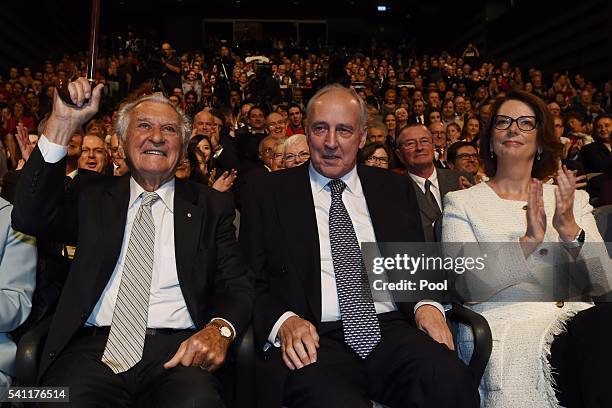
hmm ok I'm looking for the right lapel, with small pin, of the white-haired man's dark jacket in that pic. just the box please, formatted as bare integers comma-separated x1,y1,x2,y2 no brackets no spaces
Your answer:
174,179,206,326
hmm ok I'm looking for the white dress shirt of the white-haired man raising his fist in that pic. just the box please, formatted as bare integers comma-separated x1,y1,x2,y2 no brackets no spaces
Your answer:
38,135,236,333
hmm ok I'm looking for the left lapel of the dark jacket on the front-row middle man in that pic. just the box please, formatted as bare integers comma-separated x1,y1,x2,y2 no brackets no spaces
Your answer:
274,164,321,321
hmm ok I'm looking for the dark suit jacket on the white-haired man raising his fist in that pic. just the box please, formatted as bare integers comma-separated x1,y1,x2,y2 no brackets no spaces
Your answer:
13,148,253,379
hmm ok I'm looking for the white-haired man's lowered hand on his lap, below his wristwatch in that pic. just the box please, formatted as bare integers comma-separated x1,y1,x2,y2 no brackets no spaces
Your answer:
164,325,230,372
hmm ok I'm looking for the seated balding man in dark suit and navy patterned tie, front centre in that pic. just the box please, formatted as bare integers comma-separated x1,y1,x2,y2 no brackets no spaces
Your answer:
240,84,478,407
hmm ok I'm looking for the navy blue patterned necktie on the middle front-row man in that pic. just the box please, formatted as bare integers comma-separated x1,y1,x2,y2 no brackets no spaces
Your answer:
329,179,381,358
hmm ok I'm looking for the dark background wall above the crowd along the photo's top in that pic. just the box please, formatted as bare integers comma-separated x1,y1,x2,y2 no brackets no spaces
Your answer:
0,0,612,80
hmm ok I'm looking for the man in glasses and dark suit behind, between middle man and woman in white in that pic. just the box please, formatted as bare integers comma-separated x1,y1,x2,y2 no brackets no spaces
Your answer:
396,124,468,242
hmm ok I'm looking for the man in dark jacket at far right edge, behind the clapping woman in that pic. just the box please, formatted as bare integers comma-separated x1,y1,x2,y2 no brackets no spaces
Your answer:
580,113,612,173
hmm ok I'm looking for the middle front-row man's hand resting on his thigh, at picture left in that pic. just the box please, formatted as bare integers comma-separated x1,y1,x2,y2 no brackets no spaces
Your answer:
278,316,319,370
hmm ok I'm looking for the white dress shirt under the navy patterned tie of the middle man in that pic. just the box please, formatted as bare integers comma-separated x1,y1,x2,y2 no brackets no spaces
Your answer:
264,163,444,350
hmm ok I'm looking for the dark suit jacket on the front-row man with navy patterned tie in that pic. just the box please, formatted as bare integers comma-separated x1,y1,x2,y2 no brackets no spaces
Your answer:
240,164,423,407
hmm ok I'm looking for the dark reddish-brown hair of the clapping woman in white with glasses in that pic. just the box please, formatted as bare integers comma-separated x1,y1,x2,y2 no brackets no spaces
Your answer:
480,91,563,179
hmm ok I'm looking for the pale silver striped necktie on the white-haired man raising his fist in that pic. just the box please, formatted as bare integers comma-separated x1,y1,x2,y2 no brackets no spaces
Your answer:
102,192,159,374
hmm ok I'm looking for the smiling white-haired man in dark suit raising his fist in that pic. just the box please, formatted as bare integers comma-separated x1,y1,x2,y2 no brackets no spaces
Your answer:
13,78,252,407
